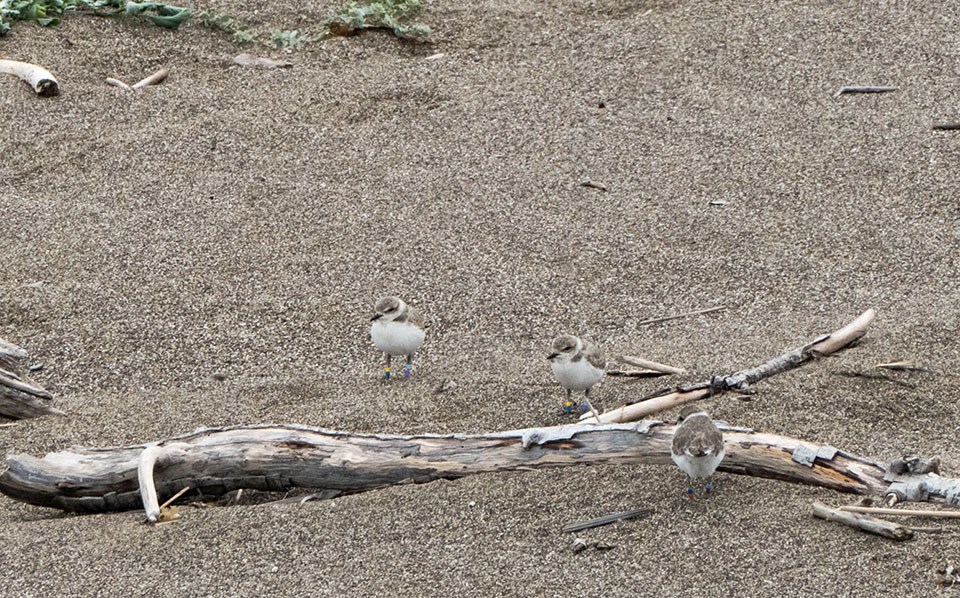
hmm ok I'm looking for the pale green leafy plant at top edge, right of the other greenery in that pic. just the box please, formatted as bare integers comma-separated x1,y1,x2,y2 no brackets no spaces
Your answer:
326,0,430,40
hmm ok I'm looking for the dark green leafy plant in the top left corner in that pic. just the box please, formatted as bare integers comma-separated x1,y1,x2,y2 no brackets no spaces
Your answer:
0,0,192,35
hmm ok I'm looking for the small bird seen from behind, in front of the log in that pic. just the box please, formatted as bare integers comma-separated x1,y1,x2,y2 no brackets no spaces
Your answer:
670,405,724,498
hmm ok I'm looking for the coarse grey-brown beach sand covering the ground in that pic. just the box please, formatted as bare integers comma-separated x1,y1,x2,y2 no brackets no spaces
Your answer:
0,0,960,596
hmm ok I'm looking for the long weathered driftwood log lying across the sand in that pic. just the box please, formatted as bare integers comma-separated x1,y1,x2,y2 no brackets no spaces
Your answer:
0,421,960,520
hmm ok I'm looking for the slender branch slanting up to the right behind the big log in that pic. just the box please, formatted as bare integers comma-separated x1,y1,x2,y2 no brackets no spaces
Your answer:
580,309,876,423
